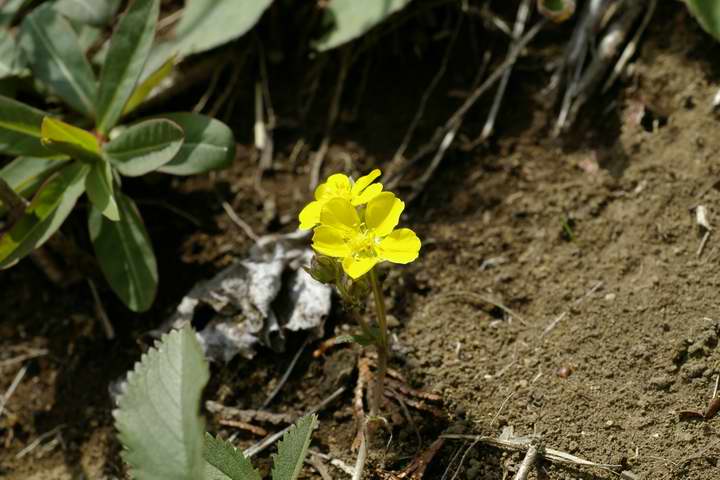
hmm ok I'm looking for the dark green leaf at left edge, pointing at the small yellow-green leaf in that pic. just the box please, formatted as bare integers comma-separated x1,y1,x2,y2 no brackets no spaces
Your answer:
0,92,56,157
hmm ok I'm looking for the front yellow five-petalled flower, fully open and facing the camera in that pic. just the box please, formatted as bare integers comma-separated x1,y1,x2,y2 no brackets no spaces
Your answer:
313,192,420,279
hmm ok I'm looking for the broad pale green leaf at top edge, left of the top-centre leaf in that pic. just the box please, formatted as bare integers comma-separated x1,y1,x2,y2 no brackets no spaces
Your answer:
175,0,272,56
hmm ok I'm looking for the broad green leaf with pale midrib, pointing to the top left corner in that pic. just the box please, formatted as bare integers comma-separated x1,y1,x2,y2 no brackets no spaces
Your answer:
20,4,97,118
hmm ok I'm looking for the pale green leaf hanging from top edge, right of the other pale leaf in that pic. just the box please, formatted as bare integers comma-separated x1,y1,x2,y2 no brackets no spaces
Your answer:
315,0,410,51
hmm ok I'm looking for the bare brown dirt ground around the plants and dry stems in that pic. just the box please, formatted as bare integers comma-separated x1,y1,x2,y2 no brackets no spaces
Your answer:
0,4,720,480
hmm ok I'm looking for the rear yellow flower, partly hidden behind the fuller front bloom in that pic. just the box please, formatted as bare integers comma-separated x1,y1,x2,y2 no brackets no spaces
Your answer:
300,168,382,230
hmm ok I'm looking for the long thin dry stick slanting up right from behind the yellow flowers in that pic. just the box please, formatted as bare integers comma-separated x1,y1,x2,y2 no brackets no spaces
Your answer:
388,18,548,193
